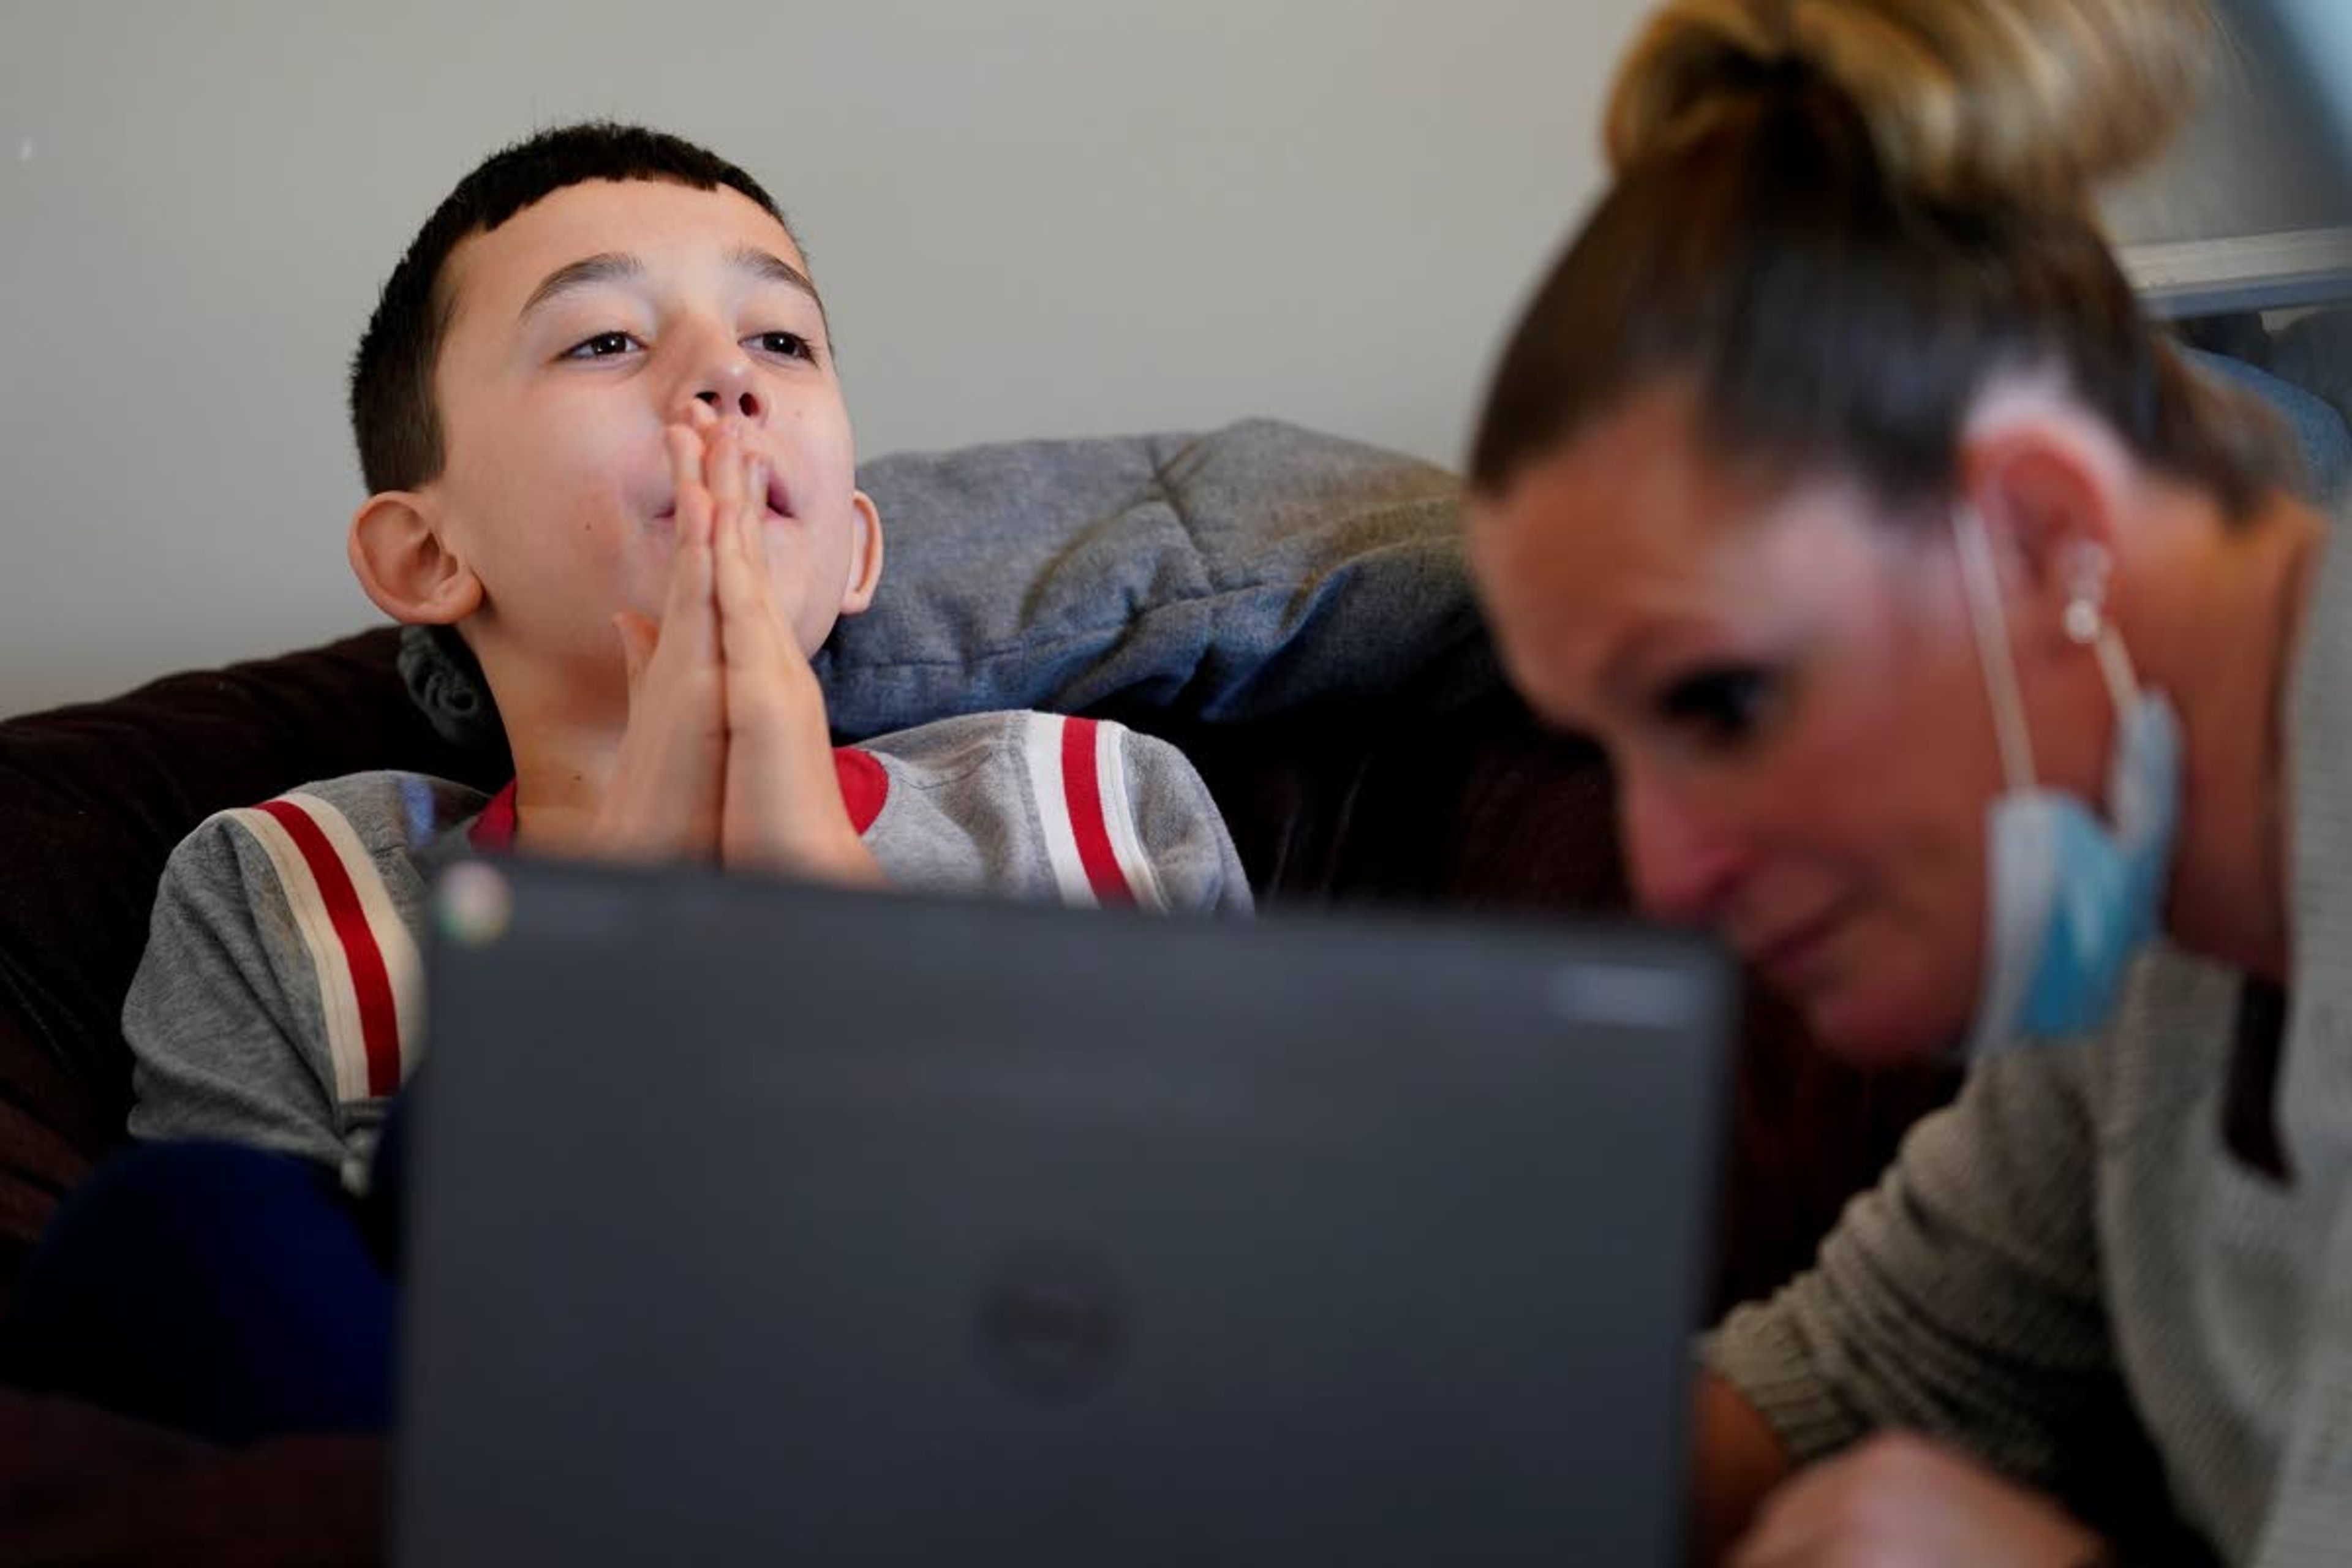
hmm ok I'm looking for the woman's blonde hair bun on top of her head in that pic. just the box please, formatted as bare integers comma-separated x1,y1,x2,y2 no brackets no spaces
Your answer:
1607,0,2218,209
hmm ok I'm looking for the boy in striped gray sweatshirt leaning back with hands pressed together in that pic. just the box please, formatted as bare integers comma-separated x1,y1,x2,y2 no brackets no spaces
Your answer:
0,124,1249,1441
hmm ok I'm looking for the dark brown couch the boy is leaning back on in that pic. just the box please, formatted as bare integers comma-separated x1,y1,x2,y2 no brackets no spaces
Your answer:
0,630,1950,1563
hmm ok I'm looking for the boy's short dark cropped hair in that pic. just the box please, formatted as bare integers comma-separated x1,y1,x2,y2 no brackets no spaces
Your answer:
350,120,800,494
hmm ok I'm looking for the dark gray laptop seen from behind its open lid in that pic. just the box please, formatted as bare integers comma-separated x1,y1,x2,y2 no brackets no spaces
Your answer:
398,863,1731,1566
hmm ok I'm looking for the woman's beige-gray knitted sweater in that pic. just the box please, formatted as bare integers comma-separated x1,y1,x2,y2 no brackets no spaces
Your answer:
1700,522,2352,1568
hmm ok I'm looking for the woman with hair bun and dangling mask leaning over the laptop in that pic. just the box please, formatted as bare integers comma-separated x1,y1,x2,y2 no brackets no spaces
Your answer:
1470,0,2352,1566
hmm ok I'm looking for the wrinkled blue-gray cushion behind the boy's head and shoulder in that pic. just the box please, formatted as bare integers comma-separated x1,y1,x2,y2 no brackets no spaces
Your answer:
402,418,1493,741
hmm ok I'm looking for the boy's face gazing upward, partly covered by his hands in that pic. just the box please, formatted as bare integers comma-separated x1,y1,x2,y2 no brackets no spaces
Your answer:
421,181,873,696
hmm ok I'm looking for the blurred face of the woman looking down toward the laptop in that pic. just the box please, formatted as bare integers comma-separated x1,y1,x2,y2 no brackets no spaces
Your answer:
1470,390,2002,1058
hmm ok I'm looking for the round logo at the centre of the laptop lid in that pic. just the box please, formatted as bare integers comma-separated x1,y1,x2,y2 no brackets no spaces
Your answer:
974,1242,1129,1406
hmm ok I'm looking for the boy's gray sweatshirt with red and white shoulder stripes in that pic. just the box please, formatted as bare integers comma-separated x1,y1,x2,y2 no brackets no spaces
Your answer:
123,712,1249,1173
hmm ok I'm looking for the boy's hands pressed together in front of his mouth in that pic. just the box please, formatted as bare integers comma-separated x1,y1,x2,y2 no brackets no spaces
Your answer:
597,404,882,881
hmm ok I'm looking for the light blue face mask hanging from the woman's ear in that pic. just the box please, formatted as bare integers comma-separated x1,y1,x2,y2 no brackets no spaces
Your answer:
1954,510,2180,1058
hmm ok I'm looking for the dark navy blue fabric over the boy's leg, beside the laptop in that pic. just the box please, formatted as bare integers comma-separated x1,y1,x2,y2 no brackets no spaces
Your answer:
0,1119,398,1444
